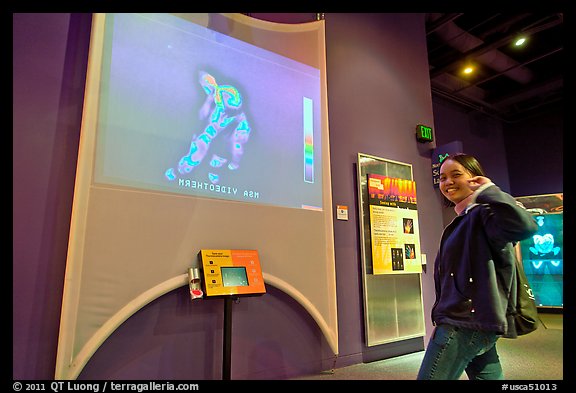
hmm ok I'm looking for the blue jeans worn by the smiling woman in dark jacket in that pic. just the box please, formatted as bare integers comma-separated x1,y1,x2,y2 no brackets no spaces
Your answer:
417,325,504,380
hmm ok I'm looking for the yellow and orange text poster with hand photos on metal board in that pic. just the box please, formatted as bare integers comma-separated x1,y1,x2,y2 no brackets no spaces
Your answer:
367,174,422,274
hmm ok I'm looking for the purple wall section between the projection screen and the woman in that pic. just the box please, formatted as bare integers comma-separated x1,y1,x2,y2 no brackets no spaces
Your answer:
326,14,442,365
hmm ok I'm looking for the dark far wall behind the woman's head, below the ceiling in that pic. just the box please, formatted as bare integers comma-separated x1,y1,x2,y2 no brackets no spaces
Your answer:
433,98,564,196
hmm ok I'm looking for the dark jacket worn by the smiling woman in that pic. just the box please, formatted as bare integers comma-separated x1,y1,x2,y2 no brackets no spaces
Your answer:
432,183,538,336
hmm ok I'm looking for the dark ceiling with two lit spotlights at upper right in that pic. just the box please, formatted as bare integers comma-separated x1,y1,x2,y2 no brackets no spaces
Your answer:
426,12,565,123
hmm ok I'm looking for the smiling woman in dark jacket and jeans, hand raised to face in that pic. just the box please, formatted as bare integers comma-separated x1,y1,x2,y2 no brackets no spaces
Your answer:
418,153,537,380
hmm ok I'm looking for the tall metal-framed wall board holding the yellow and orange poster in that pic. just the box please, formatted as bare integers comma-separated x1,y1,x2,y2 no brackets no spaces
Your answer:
357,153,425,349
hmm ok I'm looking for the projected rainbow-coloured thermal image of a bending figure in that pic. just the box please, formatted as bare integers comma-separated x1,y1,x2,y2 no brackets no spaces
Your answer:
165,72,251,184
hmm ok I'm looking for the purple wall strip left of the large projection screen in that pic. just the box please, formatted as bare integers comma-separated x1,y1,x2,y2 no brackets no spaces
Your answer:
12,14,90,379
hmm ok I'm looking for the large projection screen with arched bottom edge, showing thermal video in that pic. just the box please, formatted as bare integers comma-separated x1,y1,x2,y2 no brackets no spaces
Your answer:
55,14,338,379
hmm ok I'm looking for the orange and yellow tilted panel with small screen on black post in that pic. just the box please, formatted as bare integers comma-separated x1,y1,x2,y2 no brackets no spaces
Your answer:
198,250,266,296
